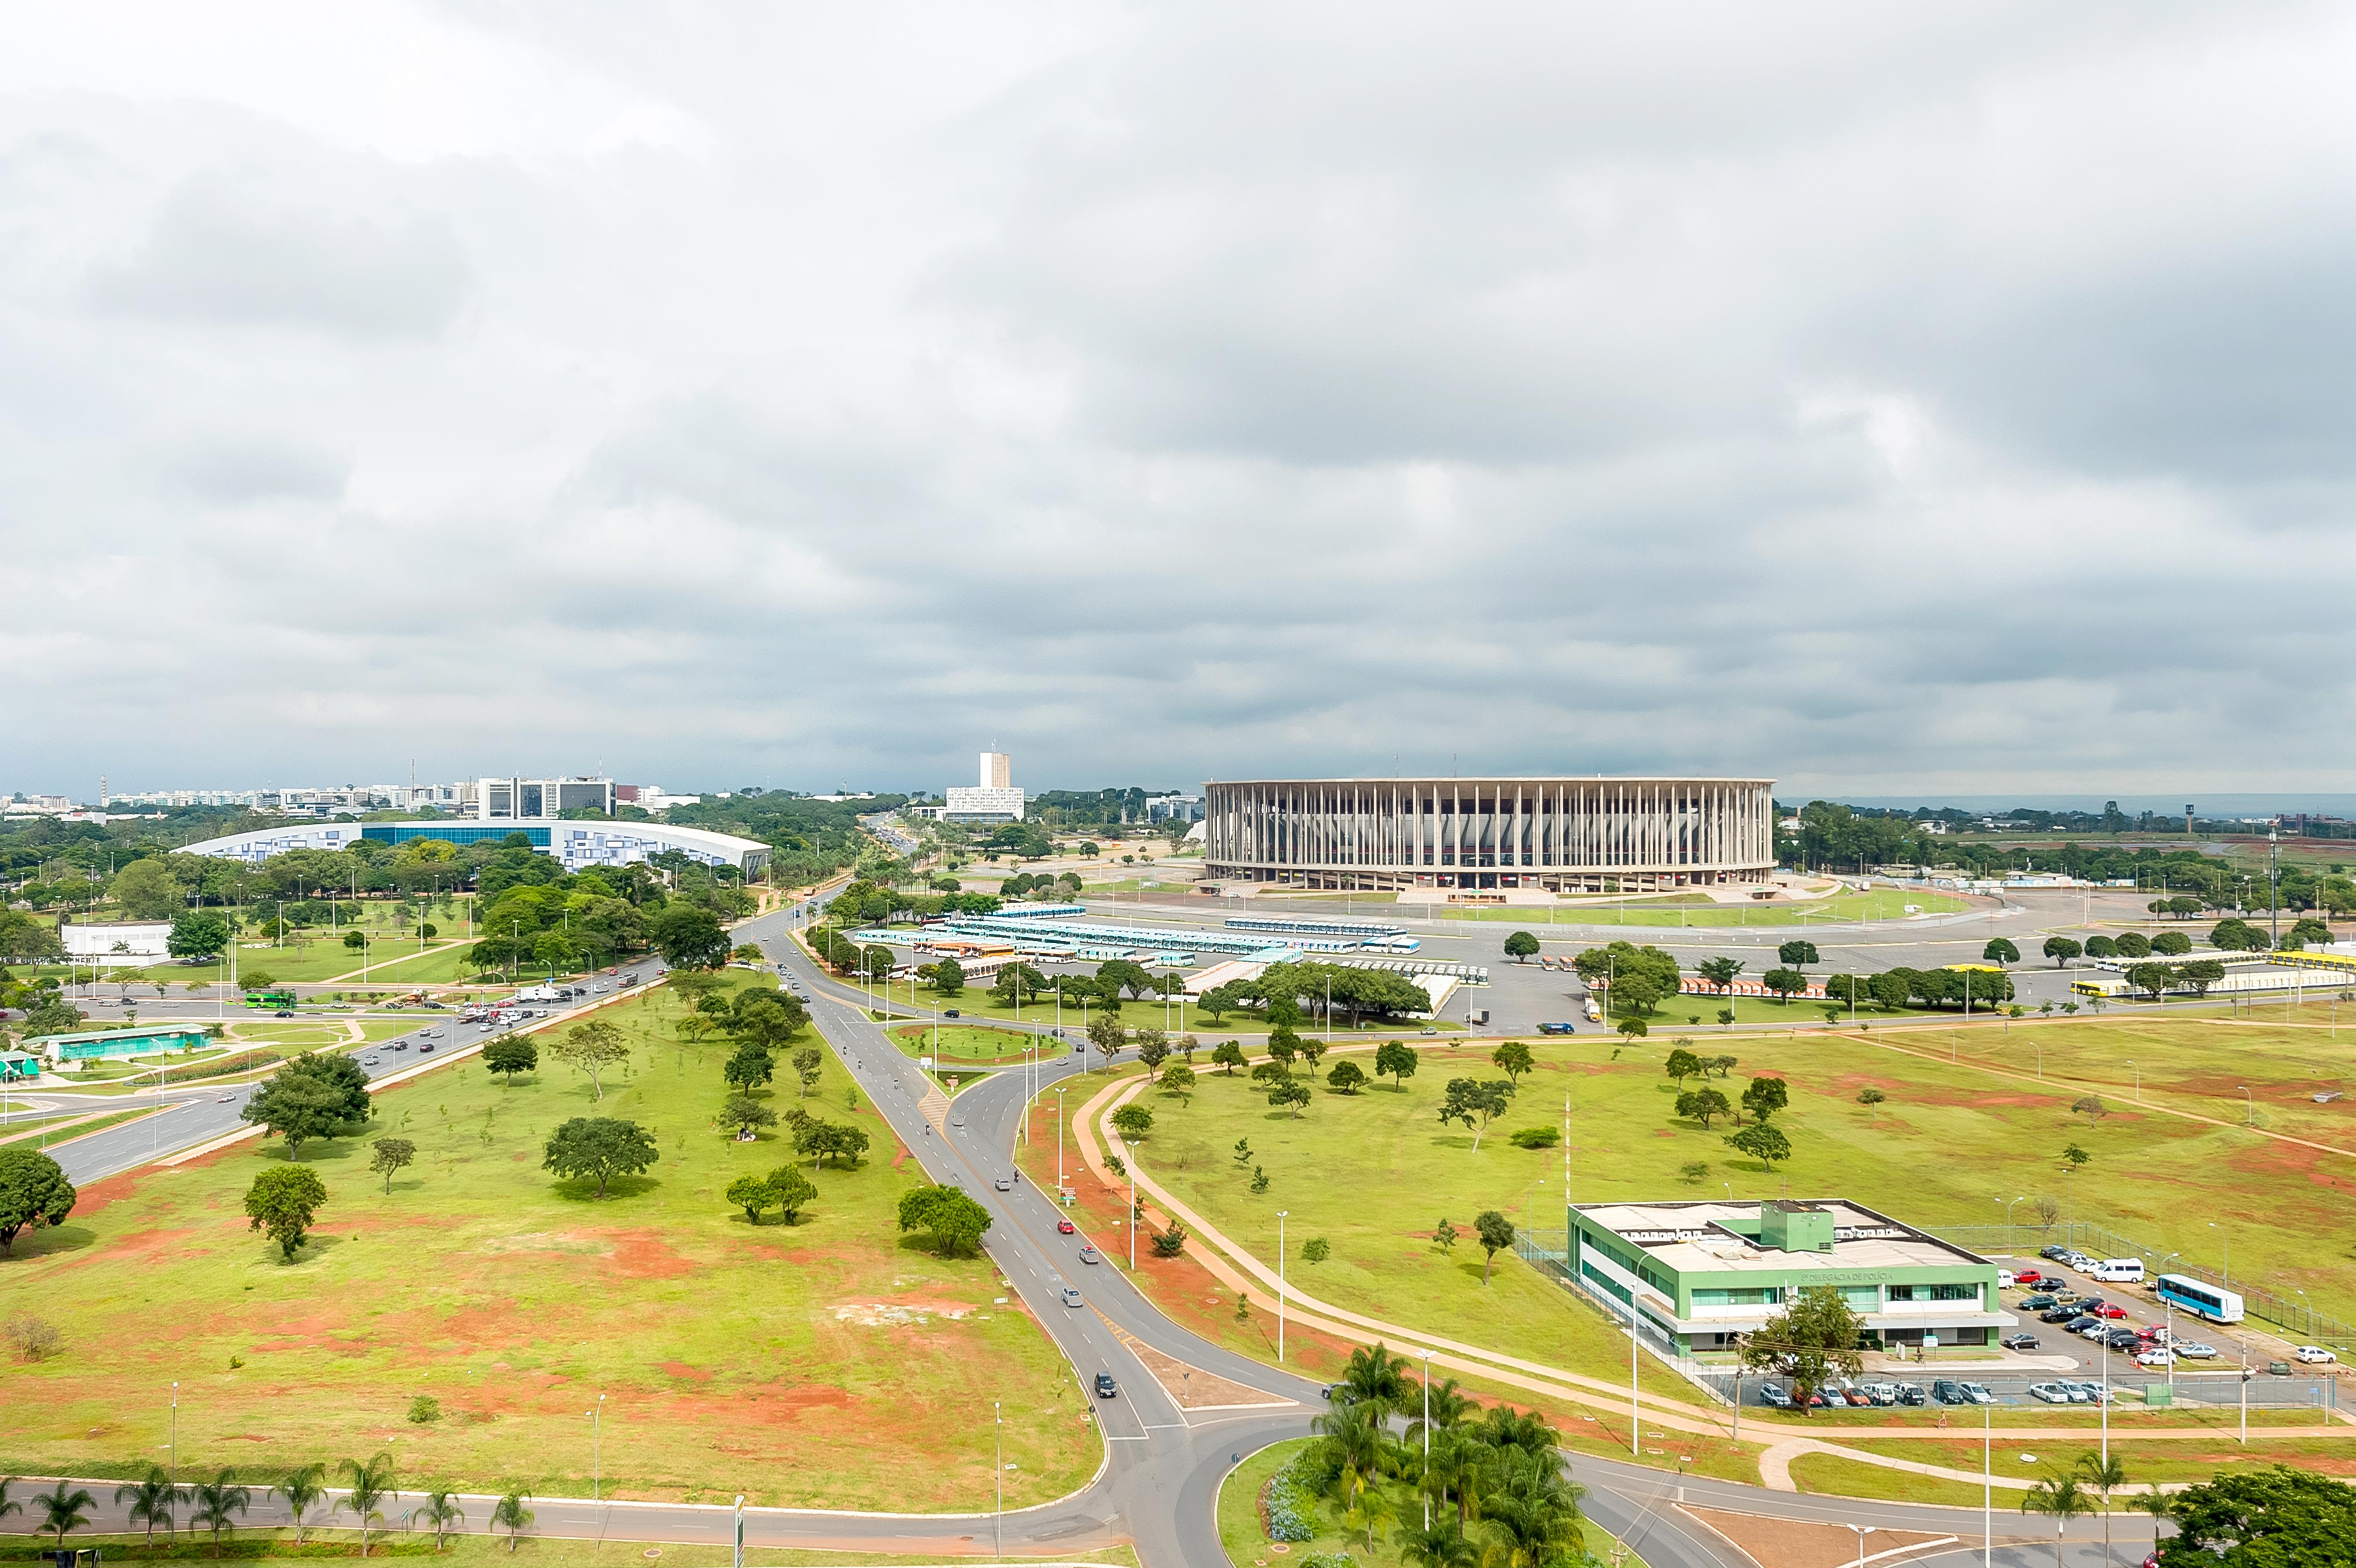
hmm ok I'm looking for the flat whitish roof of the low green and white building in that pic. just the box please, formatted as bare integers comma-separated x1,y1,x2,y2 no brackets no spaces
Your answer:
1574,1198,1986,1274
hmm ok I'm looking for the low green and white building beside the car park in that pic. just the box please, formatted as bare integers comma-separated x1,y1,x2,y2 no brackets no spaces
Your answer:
1567,1198,2019,1356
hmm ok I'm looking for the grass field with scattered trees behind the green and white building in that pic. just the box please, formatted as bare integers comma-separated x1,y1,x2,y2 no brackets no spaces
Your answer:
1145,1019,2356,1375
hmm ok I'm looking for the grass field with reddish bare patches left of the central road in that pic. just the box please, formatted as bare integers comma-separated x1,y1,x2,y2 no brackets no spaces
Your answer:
0,991,1100,1512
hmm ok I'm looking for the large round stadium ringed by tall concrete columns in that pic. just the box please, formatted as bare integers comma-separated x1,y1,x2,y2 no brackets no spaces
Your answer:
1204,777,1774,893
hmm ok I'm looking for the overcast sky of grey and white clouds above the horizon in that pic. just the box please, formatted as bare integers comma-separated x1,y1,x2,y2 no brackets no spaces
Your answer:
0,0,2356,798
